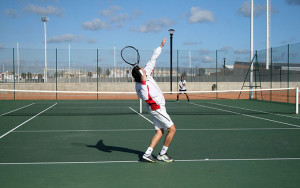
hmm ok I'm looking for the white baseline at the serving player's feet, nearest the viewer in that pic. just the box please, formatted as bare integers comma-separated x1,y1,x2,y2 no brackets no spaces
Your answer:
0,158,300,165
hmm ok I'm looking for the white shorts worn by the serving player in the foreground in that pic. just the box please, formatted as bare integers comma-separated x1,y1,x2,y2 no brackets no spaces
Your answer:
149,106,174,130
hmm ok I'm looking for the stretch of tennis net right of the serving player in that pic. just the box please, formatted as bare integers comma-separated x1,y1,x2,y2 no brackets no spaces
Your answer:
164,88,299,115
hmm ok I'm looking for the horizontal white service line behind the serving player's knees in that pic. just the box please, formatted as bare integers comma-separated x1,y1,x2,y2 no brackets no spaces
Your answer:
14,128,300,133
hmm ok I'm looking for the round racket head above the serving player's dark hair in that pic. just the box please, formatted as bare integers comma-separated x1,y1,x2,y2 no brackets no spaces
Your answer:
121,46,140,66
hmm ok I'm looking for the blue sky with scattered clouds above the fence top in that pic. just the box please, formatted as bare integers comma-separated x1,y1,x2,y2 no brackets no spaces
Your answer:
0,0,300,52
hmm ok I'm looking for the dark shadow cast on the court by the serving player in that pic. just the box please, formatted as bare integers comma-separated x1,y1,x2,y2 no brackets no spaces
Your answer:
86,140,144,161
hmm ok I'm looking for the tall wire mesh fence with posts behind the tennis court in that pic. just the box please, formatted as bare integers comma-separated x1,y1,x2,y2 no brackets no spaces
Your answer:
0,43,300,91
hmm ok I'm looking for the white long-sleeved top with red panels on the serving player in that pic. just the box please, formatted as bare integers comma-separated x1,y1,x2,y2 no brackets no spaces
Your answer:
135,47,165,110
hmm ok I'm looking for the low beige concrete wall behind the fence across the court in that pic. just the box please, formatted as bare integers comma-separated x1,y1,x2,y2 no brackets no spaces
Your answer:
0,82,300,92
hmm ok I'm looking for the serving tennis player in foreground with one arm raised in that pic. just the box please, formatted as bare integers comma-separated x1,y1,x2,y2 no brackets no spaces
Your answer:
132,38,176,162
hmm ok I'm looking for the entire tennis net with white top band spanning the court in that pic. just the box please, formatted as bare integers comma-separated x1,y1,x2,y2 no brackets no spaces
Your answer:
0,88,299,115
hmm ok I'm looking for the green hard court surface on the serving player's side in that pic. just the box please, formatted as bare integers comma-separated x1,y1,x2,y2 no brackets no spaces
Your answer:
0,100,300,188
